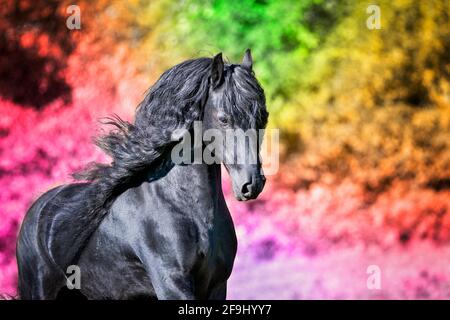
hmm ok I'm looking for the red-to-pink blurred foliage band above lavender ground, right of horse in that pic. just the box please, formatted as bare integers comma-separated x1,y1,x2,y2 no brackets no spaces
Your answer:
227,178,450,256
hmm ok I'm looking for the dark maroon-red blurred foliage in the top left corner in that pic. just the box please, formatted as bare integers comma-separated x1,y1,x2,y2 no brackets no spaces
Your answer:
0,0,74,108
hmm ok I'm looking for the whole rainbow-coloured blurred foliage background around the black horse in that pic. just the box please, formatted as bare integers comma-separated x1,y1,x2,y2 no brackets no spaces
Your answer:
0,0,450,299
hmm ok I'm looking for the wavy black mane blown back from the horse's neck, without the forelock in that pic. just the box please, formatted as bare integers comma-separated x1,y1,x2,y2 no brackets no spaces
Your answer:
74,58,212,182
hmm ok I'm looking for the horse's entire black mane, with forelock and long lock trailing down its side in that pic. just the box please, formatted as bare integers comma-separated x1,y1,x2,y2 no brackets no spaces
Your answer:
43,58,268,267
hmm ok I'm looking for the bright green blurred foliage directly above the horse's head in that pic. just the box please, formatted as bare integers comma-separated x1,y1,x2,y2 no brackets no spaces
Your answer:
174,0,321,106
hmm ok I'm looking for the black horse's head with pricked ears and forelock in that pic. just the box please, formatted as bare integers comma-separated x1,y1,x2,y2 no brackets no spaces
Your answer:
203,50,268,201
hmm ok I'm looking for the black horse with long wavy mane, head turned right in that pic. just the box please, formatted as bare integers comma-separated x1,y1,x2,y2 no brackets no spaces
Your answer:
17,50,268,299
